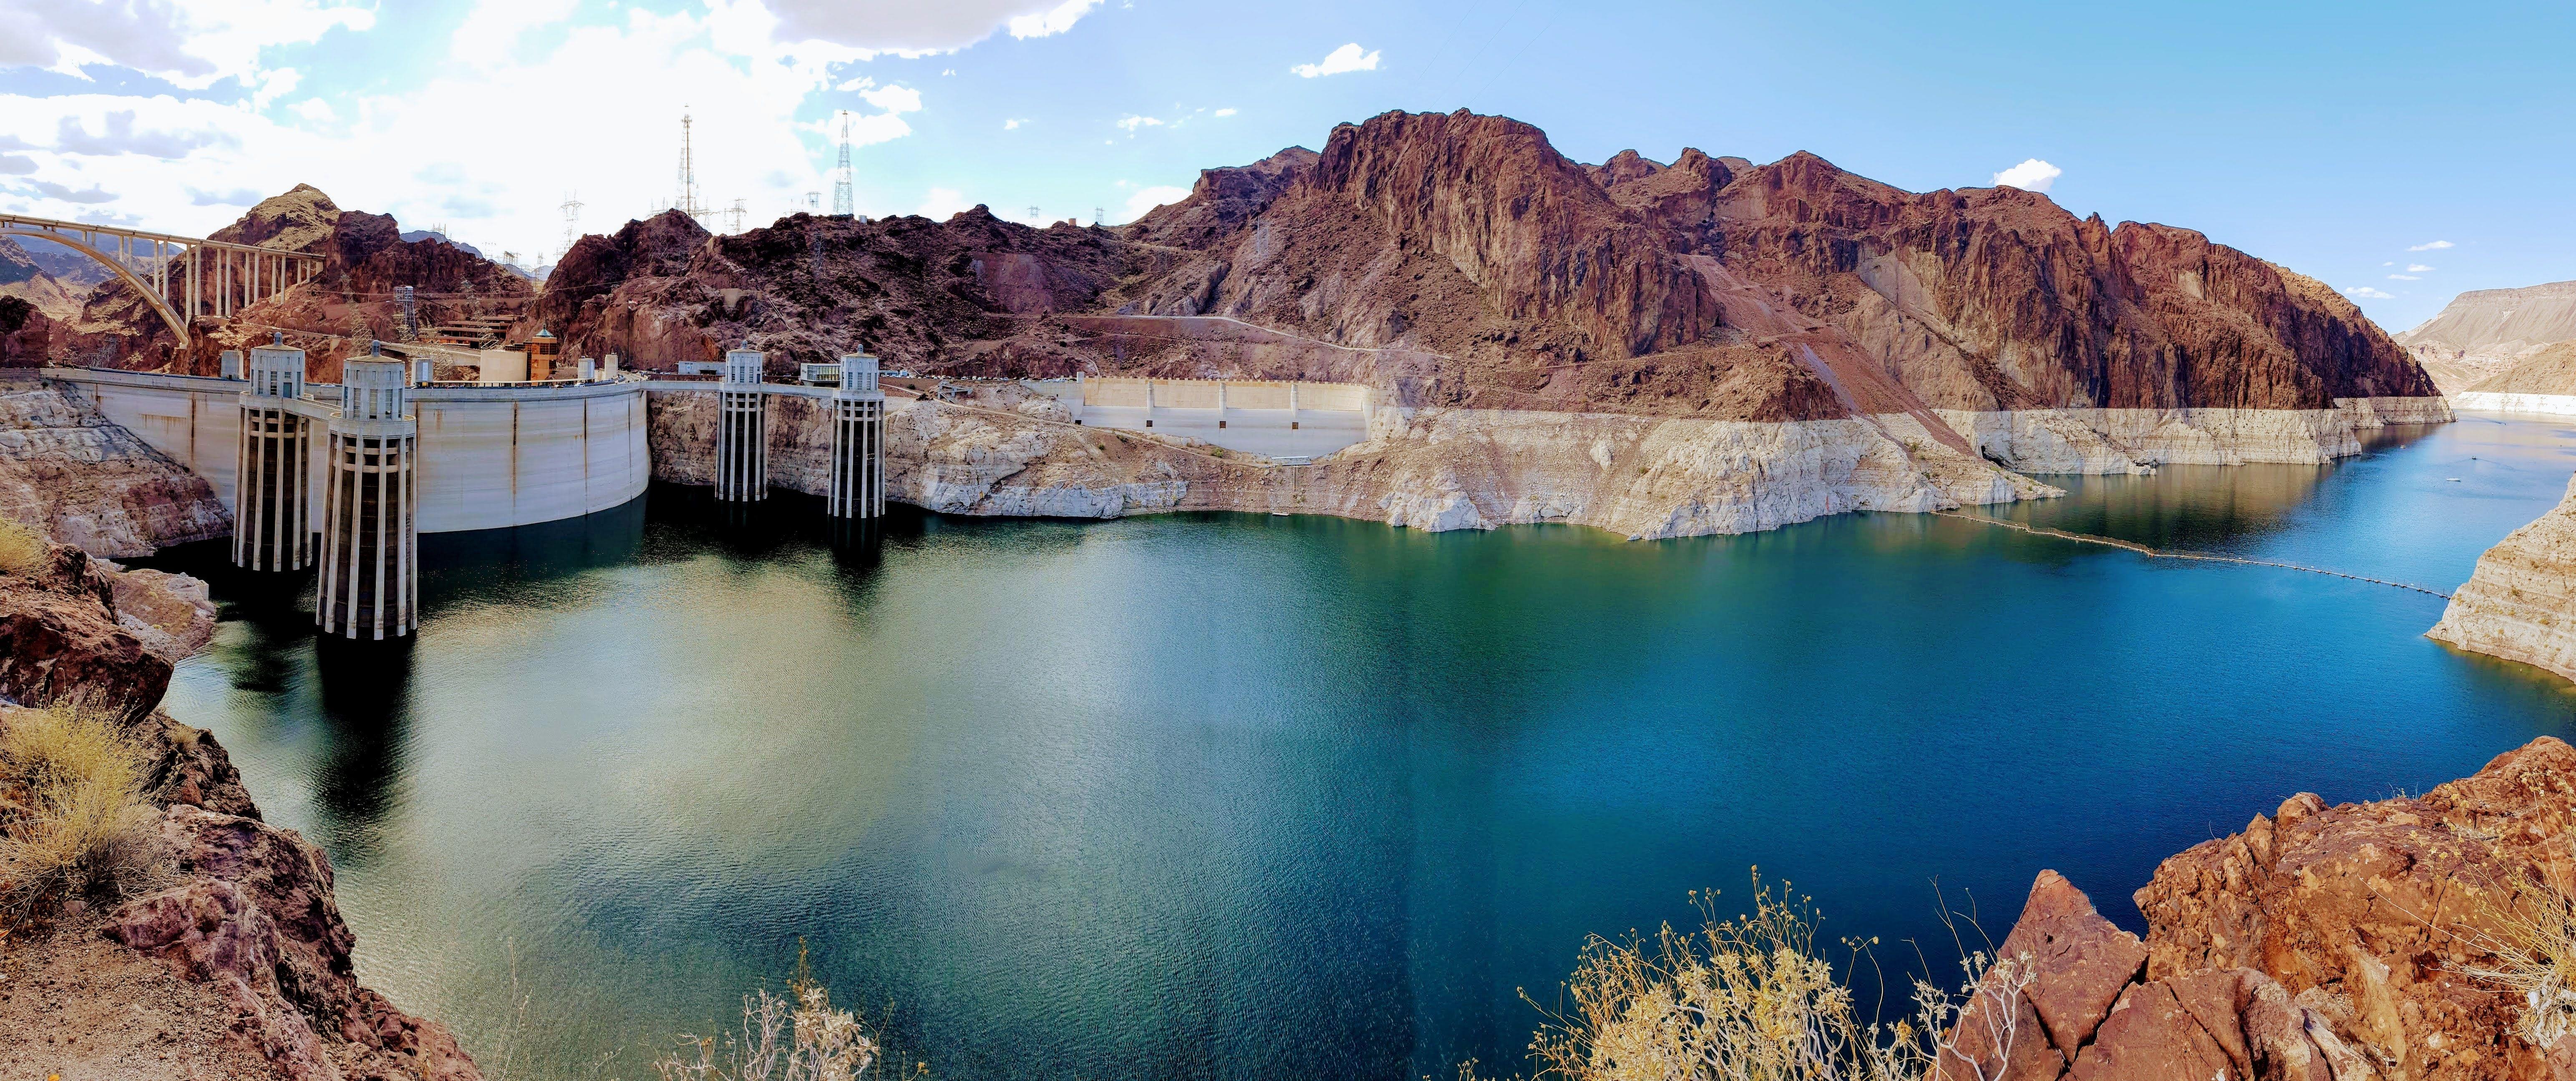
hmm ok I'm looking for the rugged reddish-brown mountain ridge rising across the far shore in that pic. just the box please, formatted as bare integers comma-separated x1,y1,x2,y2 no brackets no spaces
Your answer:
518,113,2450,535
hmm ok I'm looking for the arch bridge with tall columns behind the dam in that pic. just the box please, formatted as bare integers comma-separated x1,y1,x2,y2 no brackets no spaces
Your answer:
0,214,322,345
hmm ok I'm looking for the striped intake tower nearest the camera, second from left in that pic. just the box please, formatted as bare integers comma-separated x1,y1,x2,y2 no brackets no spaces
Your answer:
314,358,420,641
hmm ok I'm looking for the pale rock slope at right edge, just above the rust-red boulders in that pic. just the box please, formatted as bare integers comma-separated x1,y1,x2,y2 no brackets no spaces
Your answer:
2424,471,2576,680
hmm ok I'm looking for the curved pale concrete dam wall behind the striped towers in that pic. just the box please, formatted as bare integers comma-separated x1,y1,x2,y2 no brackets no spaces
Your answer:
52,370,652,533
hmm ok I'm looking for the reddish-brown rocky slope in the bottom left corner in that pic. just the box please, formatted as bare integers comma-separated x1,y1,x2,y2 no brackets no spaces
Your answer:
0,535,479,1081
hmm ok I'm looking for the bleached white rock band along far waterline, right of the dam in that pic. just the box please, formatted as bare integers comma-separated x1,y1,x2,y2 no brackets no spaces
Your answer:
647,394,2056,538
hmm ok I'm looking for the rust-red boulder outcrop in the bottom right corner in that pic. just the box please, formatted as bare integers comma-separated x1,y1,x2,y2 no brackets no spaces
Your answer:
1942,736,2576,1081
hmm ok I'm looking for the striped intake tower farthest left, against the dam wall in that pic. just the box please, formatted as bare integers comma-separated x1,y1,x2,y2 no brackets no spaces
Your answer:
227,335,312,572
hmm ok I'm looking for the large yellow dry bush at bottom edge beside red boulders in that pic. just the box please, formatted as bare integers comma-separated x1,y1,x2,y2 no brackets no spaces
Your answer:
1530,875,2032,1081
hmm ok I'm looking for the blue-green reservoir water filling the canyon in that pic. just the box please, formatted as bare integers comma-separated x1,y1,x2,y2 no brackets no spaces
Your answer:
167,420,2576,1078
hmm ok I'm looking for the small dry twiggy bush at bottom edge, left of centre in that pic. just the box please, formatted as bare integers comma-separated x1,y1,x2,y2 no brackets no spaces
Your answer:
652,945,930,1081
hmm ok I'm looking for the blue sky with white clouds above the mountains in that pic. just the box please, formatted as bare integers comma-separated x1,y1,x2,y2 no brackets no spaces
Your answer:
0,0,2576,330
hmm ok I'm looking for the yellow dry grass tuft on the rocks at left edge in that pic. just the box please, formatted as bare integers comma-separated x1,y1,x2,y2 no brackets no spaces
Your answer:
0,703,160,916
